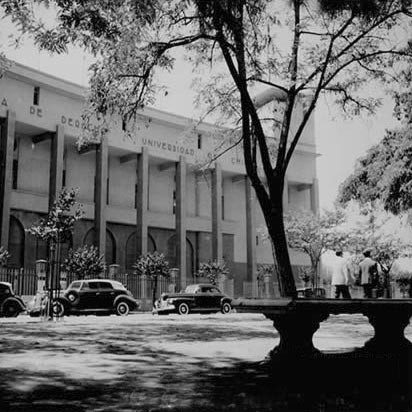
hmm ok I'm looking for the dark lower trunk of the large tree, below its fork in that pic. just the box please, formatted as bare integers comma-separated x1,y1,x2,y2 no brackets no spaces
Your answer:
263,204,297,298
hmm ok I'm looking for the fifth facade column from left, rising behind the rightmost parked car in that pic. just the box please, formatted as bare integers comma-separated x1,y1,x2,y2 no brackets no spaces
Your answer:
176,156,187,288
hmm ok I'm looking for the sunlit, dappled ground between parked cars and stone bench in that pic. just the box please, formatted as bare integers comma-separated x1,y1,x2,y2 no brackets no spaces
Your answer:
0,313,412,412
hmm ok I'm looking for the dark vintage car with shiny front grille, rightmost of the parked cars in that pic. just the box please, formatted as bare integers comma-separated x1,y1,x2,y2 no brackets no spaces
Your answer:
154,283,232,315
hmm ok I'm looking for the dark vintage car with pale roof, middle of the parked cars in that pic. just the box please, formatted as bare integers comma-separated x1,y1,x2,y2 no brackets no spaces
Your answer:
52,279,139,317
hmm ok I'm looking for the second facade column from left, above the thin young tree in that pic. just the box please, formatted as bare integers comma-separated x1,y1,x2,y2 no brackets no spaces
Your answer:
49,125,64,210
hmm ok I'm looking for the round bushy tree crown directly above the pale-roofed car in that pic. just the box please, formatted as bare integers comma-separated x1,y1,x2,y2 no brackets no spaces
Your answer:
63,245,106,279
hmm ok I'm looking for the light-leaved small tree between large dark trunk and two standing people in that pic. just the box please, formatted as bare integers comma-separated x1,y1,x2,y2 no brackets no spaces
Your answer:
285,209,348,288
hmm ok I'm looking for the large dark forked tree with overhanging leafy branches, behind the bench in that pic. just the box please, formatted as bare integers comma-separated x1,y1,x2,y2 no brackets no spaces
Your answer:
0,0,412,296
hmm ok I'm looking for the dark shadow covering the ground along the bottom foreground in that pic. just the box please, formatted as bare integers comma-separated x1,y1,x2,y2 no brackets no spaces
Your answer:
0,353,412,412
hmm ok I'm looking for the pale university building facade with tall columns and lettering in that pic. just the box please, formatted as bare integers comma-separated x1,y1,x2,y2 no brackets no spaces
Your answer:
0,64,318,295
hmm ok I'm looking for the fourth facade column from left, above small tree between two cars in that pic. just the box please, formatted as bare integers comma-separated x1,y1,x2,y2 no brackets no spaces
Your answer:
136,147,149,256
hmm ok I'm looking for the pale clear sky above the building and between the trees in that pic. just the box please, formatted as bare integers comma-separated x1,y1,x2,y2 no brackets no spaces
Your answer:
0,20,397,209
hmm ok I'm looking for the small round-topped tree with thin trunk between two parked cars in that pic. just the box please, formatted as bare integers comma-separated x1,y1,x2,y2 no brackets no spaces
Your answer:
133,252,170,307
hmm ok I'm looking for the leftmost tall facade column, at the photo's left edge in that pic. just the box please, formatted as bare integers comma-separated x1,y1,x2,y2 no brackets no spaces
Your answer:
0,110,16,249
